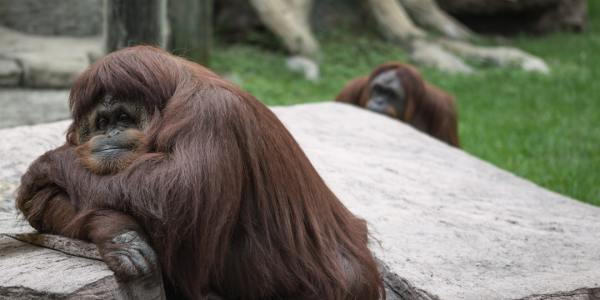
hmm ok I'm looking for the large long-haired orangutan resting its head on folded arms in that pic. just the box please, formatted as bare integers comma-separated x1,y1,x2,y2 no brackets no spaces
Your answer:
17,46,384,299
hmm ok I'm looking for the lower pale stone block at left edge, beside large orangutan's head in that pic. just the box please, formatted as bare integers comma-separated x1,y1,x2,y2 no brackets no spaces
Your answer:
0,89,70,128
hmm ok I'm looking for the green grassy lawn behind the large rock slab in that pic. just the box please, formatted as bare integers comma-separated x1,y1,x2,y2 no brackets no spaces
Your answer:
212,0,600,205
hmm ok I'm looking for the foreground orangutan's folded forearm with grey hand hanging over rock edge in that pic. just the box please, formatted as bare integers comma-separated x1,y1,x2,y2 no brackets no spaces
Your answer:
16,147,157,280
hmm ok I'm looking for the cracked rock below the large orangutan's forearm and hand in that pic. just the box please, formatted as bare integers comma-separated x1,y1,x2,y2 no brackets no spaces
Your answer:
0,212,165,300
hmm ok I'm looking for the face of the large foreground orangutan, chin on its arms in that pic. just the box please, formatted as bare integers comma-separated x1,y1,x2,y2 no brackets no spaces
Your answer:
77,96,148,174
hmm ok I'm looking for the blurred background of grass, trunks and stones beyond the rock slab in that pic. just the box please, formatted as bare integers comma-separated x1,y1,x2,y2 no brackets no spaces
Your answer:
0,0,600,205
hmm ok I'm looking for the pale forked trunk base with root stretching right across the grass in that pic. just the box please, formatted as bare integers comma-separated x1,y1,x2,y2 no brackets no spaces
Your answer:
368,0,550,74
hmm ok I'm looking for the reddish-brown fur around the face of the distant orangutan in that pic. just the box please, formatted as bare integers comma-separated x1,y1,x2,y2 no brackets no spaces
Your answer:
335,62,460,147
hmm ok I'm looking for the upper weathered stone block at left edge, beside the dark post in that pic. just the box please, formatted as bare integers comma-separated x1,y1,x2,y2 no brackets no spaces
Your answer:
0,27,102,88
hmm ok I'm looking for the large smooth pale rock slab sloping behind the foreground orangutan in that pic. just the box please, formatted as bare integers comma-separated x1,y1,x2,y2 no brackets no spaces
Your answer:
0,103,600,299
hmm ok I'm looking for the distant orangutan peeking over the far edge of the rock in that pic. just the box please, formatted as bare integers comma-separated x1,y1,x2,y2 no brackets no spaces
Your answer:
335,62,459,147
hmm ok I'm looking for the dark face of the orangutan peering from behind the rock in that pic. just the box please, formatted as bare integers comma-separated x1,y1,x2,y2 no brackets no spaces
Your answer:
367,69,406,118
